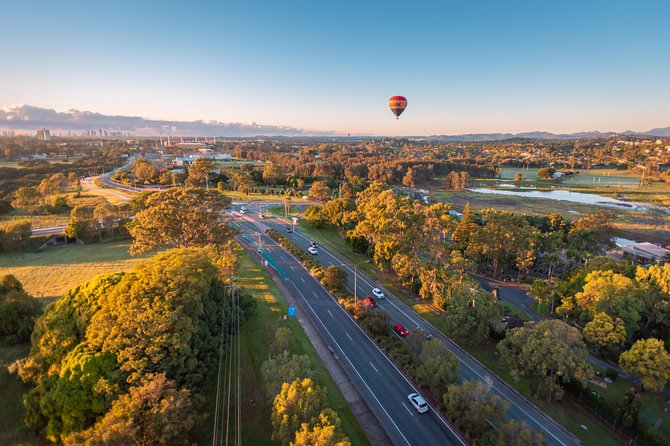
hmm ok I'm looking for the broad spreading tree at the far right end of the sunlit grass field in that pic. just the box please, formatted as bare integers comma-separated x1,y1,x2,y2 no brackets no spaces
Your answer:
127,188,234,255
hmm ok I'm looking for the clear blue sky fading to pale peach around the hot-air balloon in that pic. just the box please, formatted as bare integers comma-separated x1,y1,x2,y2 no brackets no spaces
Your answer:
0,0,670,136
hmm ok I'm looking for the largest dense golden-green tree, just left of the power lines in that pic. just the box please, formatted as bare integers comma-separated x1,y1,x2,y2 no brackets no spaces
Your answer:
86,248,228,387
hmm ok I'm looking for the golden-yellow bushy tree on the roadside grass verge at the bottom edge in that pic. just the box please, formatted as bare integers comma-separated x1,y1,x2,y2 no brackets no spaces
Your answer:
272,378,327,444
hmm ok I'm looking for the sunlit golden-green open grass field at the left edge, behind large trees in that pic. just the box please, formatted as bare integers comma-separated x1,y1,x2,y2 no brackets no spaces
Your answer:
0,240,147,298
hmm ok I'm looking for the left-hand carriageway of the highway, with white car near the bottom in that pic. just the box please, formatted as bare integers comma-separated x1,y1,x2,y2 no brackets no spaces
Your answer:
235,213,467,446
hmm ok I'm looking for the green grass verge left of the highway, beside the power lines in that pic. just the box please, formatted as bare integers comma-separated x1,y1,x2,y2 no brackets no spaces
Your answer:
200,249,369,445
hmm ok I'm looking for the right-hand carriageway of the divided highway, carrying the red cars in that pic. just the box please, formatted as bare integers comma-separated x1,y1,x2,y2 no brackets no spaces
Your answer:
236,207,580,446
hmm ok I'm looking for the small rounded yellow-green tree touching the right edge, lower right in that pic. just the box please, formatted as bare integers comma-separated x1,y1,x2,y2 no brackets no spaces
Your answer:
619,338,670,392
